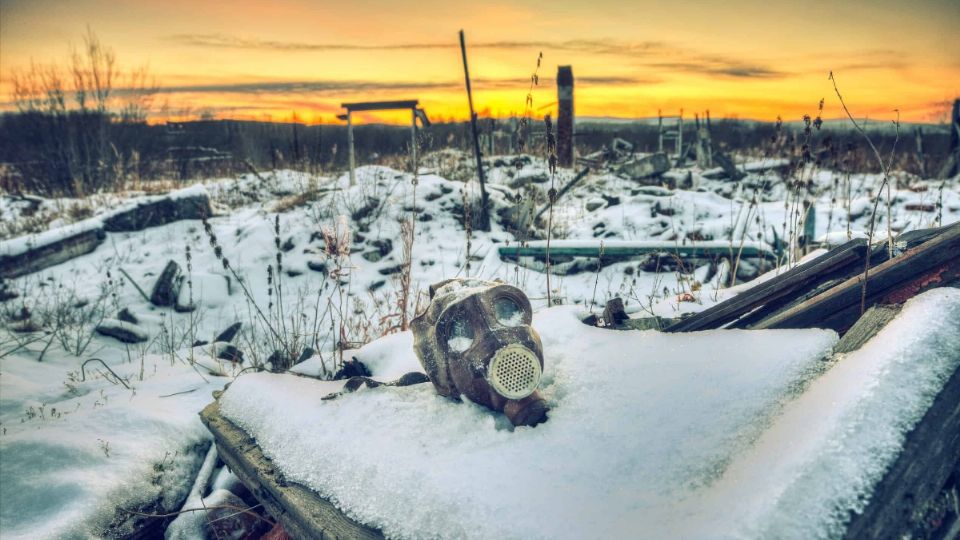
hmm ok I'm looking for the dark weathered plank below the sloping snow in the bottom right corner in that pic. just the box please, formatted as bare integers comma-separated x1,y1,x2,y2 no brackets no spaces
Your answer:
844,360,960,540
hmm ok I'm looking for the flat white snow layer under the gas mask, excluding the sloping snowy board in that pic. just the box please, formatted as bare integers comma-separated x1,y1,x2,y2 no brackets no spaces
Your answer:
221,307,836,538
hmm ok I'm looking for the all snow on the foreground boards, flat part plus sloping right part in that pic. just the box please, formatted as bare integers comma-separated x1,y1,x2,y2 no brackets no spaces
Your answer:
221,289,960,538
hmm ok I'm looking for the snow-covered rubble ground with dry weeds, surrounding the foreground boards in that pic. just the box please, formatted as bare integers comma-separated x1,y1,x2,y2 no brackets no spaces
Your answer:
0,151,960,538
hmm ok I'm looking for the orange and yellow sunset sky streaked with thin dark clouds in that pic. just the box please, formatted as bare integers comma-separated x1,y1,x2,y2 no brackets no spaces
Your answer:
0,0,960,122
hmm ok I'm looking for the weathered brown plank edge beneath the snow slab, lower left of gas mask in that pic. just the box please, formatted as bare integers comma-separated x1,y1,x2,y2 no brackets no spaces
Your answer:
200,401,383,539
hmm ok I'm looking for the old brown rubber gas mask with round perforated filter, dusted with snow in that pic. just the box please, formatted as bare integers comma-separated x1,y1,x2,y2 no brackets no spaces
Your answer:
411,278,548,426
